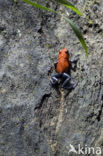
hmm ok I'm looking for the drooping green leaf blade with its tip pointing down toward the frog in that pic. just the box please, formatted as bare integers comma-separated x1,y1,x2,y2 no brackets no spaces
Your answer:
63,16,88,56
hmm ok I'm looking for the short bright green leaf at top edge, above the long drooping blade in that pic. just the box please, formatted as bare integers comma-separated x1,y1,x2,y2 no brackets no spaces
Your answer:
55,0,82,16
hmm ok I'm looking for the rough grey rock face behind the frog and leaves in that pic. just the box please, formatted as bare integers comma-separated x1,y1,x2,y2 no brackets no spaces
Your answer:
0,0,103,156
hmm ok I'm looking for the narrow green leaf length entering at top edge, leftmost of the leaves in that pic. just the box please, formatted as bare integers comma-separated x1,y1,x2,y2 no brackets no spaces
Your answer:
23,0,56,13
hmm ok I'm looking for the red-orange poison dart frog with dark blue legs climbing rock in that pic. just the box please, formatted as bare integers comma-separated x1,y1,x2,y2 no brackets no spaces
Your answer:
51,48,77,90
